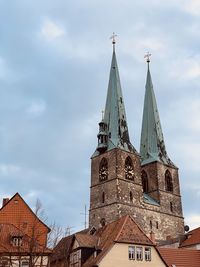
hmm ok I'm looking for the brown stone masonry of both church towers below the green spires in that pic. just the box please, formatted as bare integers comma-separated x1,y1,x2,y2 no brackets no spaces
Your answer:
89,148,184,240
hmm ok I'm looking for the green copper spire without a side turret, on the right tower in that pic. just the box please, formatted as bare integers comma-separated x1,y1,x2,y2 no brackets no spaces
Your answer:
140,53,174,166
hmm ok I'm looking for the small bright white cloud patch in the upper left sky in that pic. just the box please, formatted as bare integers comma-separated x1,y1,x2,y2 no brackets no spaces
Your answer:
40,18,65,41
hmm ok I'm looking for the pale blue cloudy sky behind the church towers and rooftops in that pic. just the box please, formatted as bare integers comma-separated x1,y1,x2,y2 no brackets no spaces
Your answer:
0,0,200,231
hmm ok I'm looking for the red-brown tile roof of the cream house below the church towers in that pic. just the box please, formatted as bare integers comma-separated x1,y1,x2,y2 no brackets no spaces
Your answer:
52,216,154,267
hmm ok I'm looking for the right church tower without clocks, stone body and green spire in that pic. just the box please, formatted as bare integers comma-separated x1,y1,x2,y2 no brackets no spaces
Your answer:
140,54,184,239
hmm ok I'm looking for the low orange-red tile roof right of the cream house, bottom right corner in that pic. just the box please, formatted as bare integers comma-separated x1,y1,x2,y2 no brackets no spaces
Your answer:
158,248,200,267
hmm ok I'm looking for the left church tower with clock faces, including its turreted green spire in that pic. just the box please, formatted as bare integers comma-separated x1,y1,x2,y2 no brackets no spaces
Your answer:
89,37,142,228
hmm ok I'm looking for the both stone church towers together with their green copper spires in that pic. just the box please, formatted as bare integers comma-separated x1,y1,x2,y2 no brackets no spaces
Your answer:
89,38,184,243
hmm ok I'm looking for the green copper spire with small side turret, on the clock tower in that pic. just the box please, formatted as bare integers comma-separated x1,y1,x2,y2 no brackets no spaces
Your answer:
95,34,135,154
